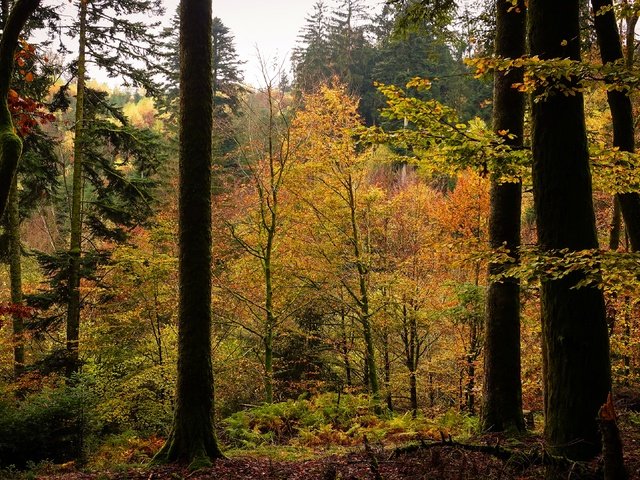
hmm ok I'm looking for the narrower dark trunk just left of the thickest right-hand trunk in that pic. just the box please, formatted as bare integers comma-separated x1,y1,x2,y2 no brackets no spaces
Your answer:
482,0,526,431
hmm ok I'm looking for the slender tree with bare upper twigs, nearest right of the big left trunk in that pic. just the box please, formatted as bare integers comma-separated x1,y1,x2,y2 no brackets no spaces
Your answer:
220,70,300,403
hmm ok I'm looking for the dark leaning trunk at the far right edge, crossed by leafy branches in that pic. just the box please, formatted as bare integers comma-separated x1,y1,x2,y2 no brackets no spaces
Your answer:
591,0,640,252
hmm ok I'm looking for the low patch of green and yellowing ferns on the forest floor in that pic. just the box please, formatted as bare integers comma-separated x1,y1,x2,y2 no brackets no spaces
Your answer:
221,393,478,451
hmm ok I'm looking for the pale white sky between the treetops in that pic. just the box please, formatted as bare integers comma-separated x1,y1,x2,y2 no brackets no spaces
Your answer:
164,0,382,86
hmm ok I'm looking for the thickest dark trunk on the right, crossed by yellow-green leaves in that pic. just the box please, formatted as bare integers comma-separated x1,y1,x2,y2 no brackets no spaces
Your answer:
529,0,611,459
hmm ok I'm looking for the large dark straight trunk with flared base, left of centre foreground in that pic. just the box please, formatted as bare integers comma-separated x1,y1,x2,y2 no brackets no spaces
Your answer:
155,0,222,468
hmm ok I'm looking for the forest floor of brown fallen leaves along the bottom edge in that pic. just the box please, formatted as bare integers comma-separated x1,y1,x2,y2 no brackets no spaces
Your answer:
8,412,640,480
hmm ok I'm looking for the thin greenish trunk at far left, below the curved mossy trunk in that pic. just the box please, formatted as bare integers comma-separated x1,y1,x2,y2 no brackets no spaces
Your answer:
7,177,25,377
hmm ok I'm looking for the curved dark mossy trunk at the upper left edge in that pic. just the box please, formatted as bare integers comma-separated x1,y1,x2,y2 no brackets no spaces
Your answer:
0,0,40,218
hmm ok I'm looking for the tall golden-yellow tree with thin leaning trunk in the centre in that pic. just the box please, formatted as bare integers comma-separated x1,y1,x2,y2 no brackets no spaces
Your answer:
292,86,381,411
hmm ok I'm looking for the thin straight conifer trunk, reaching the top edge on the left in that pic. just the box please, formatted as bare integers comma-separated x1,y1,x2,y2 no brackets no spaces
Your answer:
66,0,88,378
